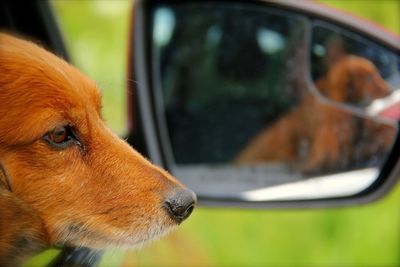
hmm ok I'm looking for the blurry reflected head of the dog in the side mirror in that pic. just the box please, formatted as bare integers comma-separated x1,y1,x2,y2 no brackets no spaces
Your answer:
323,56,391,106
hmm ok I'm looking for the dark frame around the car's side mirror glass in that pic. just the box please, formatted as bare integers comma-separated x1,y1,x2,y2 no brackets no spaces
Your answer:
128,0,400,209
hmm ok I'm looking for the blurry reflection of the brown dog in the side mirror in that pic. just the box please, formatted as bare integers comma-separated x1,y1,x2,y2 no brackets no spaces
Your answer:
235,56,396,173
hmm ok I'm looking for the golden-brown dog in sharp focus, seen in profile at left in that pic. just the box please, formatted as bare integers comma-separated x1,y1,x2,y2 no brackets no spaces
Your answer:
0,34,195,266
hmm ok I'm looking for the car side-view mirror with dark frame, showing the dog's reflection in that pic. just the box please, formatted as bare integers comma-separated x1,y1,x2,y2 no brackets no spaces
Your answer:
129,0,400,207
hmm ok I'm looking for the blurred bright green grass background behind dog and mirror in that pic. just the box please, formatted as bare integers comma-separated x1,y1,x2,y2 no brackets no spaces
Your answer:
27,0,400,267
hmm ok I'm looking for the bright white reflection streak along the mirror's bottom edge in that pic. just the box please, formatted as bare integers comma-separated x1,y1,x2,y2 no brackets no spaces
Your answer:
240,168,379,201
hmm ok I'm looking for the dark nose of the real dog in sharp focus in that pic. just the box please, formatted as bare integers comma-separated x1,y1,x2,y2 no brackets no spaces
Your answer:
164,189,197,223
